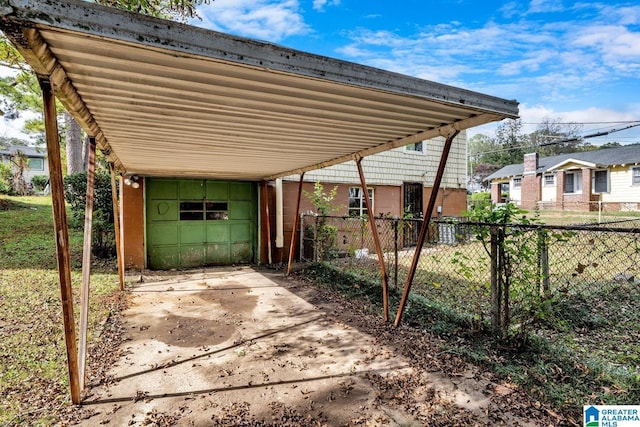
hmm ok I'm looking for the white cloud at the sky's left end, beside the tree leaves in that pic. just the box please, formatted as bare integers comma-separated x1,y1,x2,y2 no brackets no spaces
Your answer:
192,0,310,42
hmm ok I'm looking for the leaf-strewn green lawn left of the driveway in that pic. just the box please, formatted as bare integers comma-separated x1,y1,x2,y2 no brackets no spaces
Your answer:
0,196,124,425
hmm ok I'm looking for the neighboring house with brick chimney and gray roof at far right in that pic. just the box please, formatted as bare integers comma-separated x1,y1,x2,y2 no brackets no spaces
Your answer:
486,145,640,211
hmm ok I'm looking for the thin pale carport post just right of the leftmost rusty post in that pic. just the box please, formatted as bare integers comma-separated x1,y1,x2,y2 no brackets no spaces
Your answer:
78,137,96,390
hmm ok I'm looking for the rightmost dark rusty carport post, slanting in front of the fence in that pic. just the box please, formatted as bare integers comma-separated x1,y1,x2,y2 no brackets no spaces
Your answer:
394,131,459,326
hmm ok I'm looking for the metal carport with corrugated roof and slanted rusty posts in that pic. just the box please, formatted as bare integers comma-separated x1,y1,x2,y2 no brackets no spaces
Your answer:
0,0,518,403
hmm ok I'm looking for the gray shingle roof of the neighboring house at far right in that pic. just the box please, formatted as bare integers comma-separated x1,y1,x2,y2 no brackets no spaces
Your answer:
485,144,640,181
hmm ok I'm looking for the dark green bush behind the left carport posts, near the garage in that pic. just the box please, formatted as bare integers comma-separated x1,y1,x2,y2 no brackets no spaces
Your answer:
64,171,115,258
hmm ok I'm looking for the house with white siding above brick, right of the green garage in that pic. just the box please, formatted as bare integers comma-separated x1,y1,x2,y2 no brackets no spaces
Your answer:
285,132,467,217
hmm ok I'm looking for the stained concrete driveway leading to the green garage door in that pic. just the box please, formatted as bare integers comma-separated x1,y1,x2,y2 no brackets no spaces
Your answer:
76,267,544,426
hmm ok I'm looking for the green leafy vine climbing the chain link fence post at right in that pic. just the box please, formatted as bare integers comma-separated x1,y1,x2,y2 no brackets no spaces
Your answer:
460,203,572,341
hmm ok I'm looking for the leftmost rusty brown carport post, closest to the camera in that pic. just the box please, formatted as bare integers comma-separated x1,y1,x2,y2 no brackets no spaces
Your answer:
38,77,80,404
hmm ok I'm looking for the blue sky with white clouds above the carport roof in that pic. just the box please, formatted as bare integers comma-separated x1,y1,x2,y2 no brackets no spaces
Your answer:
191,0,640,145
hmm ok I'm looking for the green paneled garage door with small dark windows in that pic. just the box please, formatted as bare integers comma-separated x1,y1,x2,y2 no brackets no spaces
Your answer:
146,178,257,269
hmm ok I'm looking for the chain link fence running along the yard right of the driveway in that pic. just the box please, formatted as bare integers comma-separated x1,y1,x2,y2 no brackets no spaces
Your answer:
300,215,640,372
